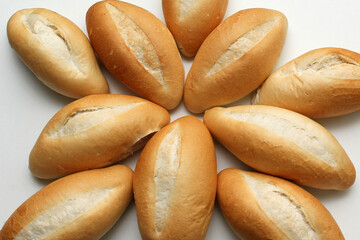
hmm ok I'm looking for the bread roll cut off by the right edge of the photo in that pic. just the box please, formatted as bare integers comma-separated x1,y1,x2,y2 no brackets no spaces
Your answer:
253,48,360,118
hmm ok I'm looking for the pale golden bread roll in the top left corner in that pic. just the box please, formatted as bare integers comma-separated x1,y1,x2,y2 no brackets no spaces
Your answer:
7,8,109,98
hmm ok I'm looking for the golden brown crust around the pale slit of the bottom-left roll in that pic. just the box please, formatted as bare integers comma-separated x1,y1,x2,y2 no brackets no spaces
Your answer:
0,165,133,240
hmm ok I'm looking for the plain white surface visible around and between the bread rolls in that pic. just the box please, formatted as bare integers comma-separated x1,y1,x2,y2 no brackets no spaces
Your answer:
0,0,360,240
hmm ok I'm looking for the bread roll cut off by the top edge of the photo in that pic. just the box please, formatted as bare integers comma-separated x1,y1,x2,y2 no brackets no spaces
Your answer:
162,0,228,57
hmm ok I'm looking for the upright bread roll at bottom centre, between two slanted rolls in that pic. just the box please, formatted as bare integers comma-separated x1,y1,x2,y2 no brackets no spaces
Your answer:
134,116,217,240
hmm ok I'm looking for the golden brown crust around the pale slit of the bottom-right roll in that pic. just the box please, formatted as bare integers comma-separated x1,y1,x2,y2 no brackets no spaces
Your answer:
217,169,344,240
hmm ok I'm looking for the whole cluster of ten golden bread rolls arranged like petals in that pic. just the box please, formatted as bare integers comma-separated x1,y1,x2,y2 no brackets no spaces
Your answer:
0,0,360,240
